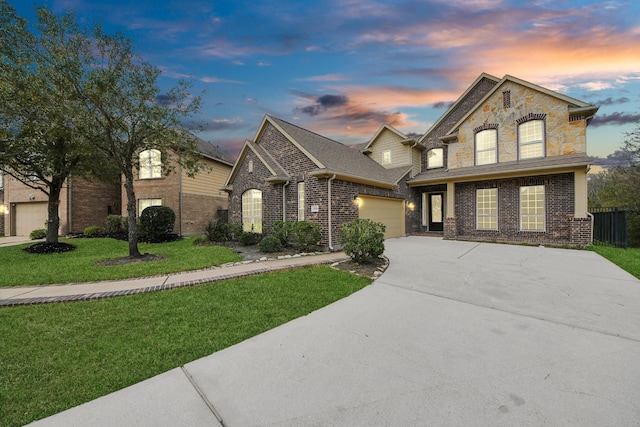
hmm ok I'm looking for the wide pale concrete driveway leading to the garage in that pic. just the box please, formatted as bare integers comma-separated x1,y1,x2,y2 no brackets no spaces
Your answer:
33,237,640,427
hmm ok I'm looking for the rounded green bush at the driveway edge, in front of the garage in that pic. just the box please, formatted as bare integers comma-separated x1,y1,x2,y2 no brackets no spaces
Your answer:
340,219,386,263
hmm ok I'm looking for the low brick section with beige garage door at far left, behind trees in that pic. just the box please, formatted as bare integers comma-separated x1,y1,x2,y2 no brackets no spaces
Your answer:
4,175,120,236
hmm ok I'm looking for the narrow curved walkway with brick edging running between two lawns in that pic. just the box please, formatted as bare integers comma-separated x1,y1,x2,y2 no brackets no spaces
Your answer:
0,252,348,306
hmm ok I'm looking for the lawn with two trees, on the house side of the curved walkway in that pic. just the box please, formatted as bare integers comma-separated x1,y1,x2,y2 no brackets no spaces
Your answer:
0,238,241,286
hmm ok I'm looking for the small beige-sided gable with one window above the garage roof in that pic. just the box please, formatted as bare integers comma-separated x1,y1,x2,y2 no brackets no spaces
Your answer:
362,124,425,176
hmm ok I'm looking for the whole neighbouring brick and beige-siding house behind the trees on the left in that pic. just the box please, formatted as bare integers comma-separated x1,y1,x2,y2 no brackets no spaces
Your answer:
0,134,233,236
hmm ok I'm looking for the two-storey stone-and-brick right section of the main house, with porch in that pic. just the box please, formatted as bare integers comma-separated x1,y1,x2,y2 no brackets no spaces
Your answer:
407,74,598,245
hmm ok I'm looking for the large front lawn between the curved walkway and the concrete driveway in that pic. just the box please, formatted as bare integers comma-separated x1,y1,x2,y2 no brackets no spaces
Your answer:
0,266,370,426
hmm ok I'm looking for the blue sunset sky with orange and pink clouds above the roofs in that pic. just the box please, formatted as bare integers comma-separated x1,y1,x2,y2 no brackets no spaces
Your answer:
9,0,640,157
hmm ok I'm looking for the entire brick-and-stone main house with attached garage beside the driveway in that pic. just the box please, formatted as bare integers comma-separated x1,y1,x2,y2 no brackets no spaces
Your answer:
224,74,598,249
